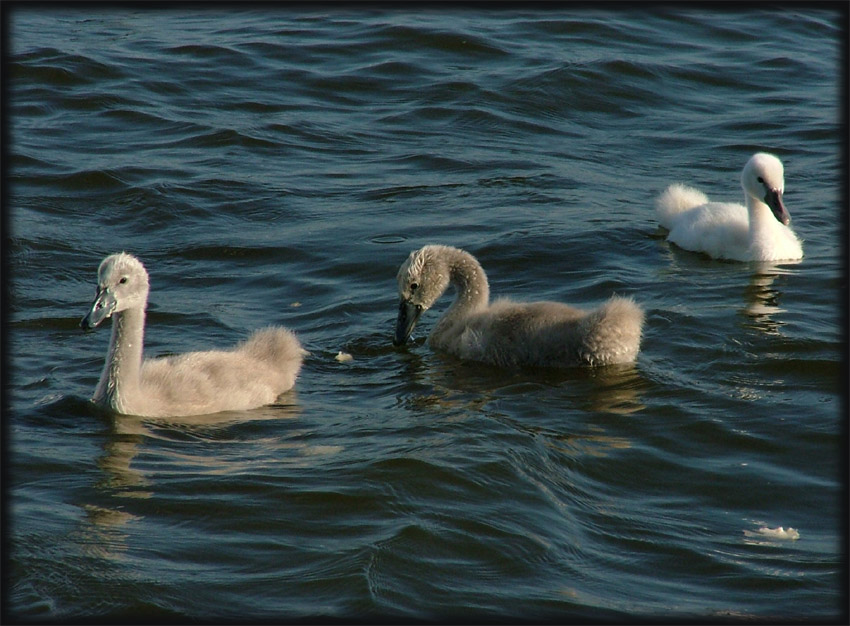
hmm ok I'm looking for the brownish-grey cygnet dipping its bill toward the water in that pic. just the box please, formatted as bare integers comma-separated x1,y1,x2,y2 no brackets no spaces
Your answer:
393,245,644,368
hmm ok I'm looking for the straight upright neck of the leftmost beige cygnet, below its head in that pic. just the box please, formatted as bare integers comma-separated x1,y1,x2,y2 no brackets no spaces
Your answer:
94,308,145,411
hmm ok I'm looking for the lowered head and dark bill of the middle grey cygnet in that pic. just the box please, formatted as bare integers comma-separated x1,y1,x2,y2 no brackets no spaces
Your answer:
393,246,449,346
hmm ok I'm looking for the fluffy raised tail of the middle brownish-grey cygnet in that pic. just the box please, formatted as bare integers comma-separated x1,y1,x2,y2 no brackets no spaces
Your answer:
580,296,644,365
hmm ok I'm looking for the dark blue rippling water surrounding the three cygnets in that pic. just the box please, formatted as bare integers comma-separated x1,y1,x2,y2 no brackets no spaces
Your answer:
3,5,847,622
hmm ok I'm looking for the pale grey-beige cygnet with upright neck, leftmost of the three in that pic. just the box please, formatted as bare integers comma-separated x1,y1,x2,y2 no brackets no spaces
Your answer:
80,252,306,417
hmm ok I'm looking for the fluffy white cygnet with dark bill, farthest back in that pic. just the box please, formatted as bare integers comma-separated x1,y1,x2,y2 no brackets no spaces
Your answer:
655,152,803,261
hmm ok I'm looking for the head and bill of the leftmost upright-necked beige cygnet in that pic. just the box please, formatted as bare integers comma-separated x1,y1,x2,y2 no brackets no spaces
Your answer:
80,252,149,330
